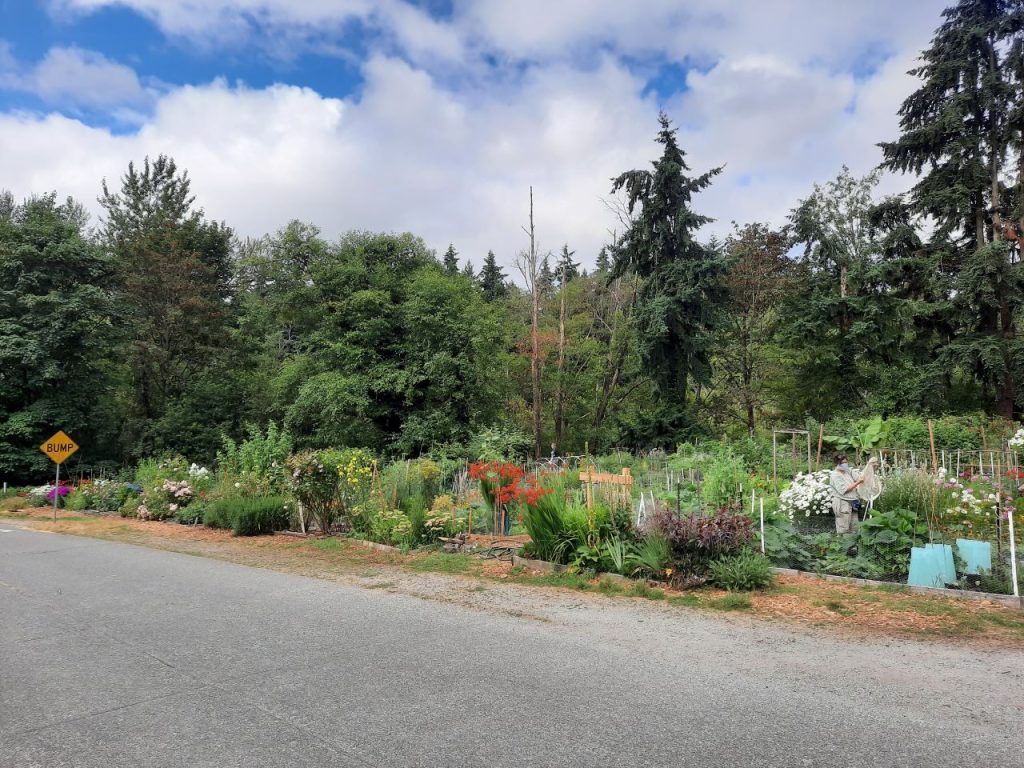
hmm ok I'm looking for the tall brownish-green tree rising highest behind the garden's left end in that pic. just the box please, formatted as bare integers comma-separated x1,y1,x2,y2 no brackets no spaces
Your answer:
99,155,231,452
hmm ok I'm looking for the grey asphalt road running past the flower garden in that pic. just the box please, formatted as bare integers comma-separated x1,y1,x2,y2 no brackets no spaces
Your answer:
0,521,1024,768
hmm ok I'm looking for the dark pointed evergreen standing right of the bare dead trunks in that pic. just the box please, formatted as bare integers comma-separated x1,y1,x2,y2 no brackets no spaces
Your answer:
611,113,727,439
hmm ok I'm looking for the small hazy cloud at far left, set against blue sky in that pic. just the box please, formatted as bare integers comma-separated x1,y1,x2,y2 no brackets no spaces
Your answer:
0,46,151,108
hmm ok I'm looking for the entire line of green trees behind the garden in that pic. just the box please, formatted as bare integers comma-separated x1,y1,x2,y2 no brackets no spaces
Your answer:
0,0,1024,479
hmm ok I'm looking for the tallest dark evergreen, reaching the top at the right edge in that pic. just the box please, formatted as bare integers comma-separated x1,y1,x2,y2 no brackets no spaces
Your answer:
882,0,1024,418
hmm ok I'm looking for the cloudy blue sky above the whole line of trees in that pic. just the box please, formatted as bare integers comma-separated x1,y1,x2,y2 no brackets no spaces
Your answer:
0,0,944,264
